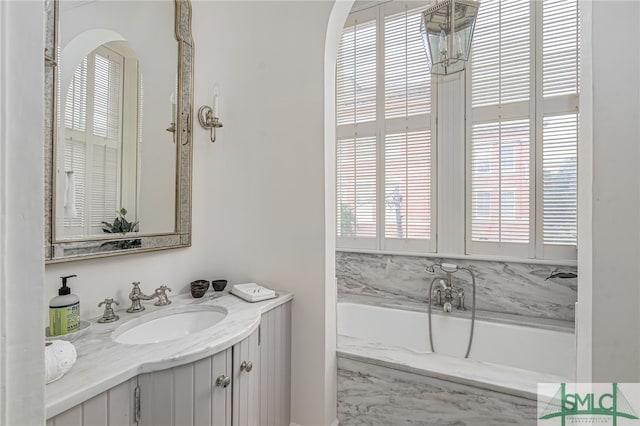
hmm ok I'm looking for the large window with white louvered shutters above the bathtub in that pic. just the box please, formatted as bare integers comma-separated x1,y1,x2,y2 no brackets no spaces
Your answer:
336,0,580,260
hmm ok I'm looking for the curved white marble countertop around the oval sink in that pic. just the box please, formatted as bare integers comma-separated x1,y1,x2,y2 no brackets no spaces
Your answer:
45,291,293,418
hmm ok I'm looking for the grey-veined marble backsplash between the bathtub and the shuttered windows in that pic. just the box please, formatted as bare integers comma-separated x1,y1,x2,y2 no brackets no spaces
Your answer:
336,252,577,322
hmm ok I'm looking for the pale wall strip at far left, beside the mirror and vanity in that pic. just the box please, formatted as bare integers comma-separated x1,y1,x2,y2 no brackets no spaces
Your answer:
0,1,44,426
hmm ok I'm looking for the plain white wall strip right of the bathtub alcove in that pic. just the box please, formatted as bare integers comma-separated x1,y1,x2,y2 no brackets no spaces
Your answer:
578,1,640,382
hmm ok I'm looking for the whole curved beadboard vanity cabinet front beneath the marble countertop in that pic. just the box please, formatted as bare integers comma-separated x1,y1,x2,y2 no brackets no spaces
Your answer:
47,302,291,426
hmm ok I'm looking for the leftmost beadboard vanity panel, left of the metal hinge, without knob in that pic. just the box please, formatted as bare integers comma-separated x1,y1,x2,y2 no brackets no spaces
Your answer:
47,377,137,426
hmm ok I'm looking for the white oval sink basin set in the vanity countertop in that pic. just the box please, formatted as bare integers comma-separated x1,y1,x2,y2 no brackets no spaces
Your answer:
111,305,227,345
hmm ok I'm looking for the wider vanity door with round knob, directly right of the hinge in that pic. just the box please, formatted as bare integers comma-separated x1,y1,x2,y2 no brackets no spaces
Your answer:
138,349,232,426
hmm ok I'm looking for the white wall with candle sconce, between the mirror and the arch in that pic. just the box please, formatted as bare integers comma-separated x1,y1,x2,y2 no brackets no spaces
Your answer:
46,1,336,425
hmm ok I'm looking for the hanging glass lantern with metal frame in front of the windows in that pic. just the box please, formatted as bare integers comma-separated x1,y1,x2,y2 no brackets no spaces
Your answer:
421,0,480,75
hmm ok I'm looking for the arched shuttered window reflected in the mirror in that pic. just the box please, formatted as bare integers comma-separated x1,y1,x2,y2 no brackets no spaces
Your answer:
64,47,123,237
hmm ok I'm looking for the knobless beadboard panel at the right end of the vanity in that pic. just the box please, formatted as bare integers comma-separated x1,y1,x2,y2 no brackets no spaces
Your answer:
257,302,291,426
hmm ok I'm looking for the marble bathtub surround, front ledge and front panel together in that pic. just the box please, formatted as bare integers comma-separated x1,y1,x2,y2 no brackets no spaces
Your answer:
338,335,570,426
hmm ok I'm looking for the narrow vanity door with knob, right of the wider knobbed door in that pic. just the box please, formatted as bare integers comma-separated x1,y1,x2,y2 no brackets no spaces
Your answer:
232,329,262,426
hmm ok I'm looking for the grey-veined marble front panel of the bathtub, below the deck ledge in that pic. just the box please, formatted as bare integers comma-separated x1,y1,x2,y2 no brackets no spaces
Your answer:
338,357,536,426
